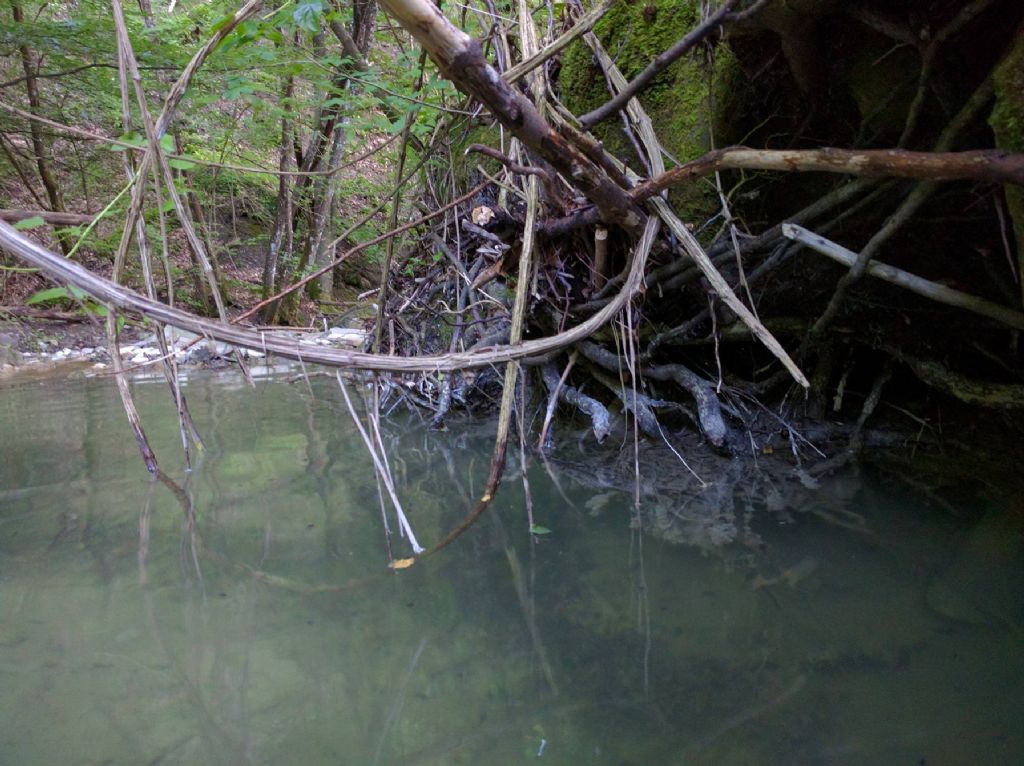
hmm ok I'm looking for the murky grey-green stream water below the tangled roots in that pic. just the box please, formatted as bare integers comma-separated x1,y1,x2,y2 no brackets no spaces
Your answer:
0,374,1024,766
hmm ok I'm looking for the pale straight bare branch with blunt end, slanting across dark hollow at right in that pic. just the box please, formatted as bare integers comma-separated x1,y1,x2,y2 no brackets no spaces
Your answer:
782,223,1024,330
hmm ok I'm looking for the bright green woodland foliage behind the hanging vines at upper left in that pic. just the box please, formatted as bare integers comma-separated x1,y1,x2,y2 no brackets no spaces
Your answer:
0,0,477,301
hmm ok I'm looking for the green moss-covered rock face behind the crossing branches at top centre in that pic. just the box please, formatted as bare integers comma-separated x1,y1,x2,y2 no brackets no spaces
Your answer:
559,0,741,220
